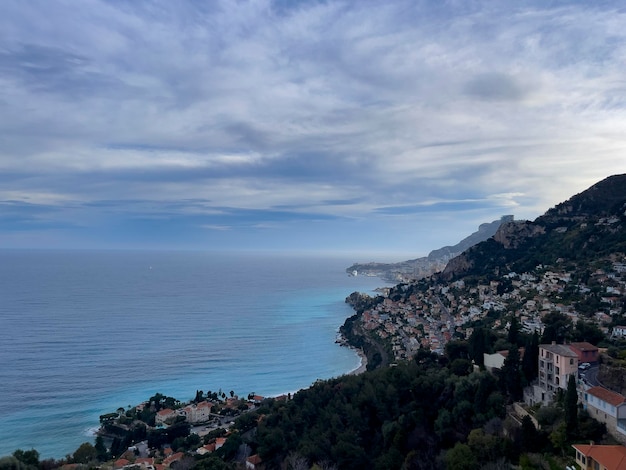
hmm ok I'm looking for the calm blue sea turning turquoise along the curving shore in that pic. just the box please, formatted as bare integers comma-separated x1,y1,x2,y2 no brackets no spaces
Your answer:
0,250,387,459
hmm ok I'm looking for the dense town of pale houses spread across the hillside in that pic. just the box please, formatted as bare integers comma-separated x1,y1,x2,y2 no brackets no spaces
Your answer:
347,258,626,362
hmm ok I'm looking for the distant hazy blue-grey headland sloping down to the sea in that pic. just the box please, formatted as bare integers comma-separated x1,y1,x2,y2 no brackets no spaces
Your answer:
346,215,513,282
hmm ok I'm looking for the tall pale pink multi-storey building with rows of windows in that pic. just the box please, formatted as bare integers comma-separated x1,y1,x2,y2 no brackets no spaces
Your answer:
524,341,578,405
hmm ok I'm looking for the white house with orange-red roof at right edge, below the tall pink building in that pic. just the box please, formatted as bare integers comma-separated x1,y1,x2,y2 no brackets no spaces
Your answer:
583,386,626,444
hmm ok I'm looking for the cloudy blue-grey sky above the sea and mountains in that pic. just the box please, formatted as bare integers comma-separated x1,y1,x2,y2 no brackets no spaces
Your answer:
0,0,626,260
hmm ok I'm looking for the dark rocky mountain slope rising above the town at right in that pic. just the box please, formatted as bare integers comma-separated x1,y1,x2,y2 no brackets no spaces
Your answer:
440,175,626,281
